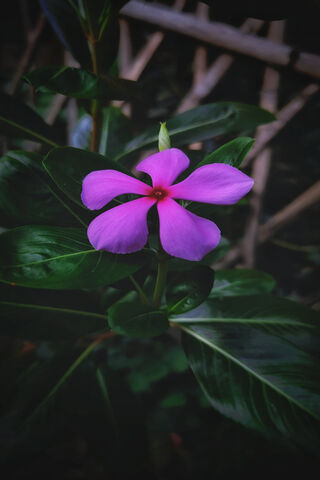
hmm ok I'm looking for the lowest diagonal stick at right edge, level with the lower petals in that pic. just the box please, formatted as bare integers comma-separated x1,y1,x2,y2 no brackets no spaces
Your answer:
212,180,320,268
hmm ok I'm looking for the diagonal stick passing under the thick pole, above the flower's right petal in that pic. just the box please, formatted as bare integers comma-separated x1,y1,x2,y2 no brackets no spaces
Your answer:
176,18,264,114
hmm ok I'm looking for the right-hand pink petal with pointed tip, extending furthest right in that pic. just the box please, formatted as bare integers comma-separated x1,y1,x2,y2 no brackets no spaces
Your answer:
170,163,254,205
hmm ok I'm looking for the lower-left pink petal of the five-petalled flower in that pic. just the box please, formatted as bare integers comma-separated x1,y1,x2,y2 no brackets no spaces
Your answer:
88,197,156,253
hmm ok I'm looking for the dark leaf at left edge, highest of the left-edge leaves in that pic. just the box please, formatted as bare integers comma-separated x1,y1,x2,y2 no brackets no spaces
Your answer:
0,93,58,147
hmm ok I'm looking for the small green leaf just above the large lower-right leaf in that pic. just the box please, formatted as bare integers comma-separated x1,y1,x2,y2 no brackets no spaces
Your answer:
210,268,276,298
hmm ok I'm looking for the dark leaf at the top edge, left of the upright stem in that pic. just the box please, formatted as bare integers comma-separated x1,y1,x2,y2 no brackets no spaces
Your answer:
40,0,91,69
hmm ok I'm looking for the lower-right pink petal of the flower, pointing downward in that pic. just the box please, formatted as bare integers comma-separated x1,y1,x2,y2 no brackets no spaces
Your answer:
157,198,220,260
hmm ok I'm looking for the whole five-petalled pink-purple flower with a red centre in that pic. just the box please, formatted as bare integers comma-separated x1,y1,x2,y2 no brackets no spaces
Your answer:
81,148,253,260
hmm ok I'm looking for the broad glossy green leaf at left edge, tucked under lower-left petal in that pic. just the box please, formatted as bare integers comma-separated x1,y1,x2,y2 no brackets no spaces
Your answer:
0,226,144,289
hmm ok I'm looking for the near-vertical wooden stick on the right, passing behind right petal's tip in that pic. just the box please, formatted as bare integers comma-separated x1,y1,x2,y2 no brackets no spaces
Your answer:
242,21,285,268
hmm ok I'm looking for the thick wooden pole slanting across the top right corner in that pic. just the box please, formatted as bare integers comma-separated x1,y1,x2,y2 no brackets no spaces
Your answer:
121,0,320,78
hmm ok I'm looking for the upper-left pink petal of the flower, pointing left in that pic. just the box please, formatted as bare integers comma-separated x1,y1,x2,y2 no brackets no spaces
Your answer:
81,170,150,210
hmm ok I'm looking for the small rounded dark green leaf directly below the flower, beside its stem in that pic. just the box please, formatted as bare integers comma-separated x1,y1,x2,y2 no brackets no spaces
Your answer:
108,301,169,338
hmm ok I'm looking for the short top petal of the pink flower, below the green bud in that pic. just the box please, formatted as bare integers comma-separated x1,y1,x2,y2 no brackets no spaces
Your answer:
136,148,190,187
